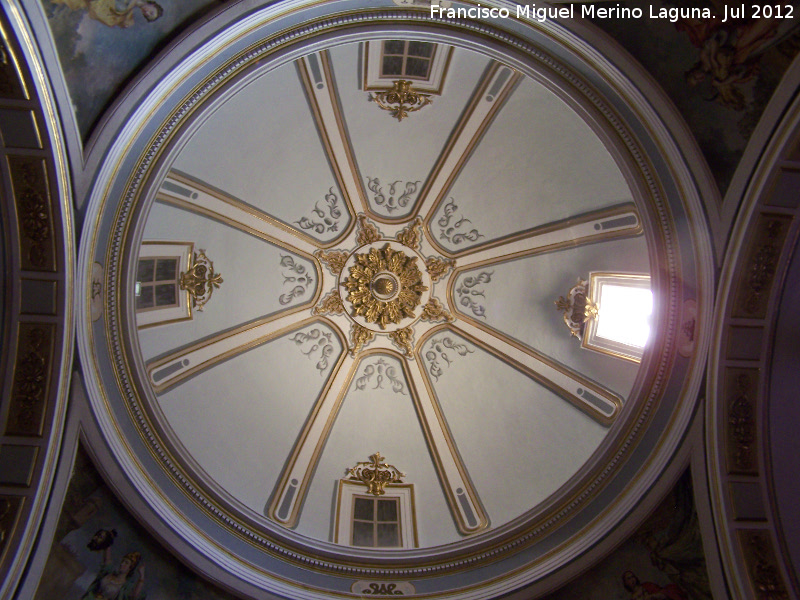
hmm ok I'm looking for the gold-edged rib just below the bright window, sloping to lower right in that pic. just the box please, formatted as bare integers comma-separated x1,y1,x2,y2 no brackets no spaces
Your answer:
434,324,622,425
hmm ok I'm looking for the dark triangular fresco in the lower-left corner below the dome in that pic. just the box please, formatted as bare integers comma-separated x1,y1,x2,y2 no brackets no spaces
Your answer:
35,440,241,600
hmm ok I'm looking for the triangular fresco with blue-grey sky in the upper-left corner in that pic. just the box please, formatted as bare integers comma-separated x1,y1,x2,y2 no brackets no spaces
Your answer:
42,0,224,139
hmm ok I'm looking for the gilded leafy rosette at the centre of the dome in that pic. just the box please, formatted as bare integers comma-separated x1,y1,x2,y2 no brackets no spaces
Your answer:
342,244,428,329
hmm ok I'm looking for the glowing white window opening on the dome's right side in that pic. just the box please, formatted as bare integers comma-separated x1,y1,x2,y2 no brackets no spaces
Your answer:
595,284,653,348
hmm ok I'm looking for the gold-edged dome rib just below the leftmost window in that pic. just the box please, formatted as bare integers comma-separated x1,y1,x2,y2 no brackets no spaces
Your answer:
147,314,328,394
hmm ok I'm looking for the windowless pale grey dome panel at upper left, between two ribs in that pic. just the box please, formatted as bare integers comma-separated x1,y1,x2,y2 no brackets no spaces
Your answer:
173,63,352,245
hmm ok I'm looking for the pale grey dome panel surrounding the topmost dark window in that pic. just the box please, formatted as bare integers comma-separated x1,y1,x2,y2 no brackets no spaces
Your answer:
330,41,491,219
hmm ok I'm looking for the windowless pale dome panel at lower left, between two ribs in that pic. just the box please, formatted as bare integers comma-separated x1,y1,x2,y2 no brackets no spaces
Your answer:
158,323,342,514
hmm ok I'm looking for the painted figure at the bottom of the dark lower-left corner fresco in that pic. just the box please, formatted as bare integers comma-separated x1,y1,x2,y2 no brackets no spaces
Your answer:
81,529,145,600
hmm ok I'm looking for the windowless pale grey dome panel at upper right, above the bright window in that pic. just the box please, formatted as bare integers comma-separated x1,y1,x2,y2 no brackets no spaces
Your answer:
429,78,633,253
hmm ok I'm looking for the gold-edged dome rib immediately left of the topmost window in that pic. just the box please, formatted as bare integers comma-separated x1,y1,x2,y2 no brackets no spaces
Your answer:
296,50,367,226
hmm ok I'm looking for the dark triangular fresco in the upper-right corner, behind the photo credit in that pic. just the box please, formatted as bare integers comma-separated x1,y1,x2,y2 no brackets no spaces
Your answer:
594,0,800,195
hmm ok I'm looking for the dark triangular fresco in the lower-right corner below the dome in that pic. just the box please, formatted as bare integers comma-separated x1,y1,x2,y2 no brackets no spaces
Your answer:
546,469,712,600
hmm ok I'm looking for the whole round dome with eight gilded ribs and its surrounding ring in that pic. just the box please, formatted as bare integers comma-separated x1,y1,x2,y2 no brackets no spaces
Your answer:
80,2,707,598
